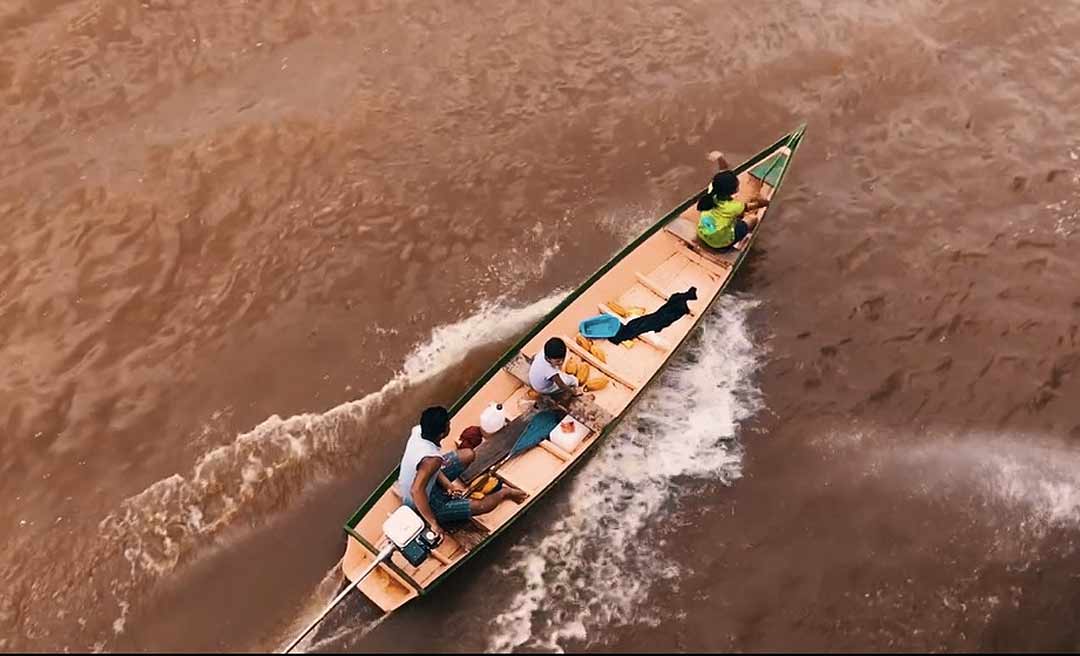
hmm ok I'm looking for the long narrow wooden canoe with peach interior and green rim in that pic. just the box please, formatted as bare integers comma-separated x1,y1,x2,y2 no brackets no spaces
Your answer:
342,126,805,613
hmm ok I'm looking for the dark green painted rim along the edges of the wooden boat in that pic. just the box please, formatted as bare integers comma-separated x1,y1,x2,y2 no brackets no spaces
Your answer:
336,123,806,594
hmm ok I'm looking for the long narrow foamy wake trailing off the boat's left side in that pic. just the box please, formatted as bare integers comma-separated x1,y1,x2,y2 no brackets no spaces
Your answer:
92,292,565,652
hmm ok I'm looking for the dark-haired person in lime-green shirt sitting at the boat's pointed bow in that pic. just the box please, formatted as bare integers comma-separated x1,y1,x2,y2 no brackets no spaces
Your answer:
698,151,769,249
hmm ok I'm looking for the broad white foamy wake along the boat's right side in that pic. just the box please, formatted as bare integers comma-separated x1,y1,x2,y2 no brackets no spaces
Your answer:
488,296,762,652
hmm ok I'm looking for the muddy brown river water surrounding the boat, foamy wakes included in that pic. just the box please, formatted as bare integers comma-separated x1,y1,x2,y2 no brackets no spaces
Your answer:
0,0,1080,652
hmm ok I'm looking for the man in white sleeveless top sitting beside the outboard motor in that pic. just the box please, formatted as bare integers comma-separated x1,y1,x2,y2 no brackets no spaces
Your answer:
397,405,526,535
